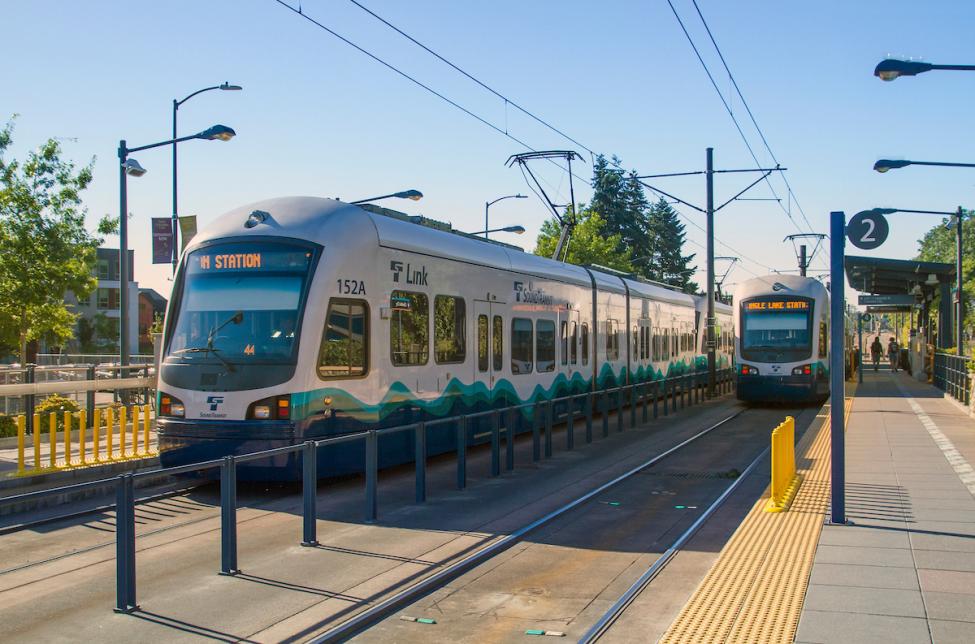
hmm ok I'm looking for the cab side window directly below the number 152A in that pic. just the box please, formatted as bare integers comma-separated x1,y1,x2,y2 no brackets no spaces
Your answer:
318,298,369,378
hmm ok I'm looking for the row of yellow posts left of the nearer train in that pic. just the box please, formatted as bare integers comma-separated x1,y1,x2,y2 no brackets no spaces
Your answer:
16,405,156,474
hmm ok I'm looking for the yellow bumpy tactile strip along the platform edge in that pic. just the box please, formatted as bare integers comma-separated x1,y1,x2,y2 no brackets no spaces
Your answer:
660,398,852,643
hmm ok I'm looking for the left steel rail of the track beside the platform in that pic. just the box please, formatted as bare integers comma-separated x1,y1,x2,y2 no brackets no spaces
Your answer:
309,409,747,644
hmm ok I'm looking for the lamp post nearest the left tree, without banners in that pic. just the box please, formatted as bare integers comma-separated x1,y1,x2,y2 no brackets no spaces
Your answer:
118,125,237,366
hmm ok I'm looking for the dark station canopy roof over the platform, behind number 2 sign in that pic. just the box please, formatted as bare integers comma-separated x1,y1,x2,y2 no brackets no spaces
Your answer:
845,255,955,295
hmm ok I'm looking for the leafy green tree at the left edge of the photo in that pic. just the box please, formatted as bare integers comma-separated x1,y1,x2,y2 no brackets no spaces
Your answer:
0,121,114,361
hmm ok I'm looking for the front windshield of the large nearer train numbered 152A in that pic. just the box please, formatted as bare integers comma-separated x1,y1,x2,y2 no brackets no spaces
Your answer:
166,242,313,365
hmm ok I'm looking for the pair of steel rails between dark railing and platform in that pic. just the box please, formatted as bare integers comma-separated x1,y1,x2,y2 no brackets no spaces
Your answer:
310,409,805,644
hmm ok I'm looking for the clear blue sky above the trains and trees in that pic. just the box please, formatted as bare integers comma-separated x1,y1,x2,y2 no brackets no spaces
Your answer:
0,0,975,297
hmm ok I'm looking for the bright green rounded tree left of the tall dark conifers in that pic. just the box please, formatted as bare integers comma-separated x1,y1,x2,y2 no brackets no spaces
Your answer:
535,209,633,273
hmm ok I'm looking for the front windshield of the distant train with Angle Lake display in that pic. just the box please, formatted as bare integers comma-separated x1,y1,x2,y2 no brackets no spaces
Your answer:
741,298,813,362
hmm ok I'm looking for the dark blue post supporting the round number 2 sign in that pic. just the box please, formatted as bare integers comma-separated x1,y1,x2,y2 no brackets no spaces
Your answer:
829,211,846,524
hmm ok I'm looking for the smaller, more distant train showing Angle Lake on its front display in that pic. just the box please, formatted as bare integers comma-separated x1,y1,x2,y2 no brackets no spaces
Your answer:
733,275,829,402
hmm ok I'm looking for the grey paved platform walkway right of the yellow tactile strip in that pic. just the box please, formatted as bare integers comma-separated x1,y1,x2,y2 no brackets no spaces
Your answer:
795,370,975,642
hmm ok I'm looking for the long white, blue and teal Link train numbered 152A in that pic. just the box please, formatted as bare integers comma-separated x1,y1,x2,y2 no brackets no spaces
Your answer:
157,197,734,479
